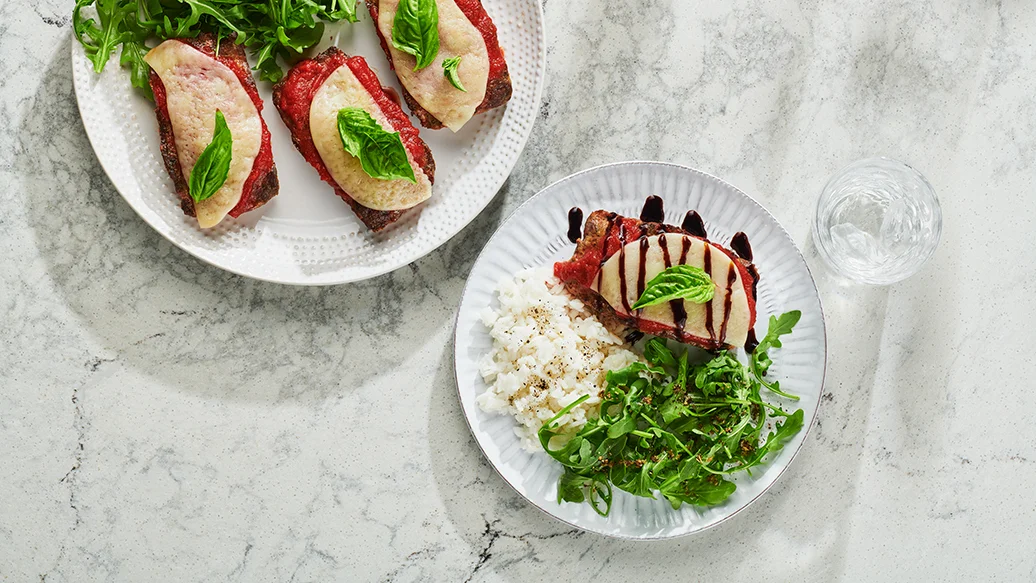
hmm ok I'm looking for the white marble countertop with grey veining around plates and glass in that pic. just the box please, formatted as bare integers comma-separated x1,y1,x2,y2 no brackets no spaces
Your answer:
0,0,1036,583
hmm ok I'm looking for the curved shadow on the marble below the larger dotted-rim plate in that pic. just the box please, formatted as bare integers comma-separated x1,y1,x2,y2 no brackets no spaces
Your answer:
23,35,509,403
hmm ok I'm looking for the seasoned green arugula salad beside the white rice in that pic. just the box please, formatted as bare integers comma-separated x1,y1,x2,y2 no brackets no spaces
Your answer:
539,312,803,516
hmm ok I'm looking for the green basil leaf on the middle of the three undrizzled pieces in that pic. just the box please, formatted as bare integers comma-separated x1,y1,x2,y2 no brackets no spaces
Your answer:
338,108,418,183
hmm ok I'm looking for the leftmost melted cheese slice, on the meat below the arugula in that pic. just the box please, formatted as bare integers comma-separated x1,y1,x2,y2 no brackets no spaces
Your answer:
144,40,262,228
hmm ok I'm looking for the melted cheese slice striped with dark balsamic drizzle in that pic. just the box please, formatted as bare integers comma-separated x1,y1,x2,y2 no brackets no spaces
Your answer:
593,233,751,346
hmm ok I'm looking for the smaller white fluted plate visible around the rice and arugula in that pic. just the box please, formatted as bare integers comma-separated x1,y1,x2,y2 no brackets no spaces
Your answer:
455,162,827,540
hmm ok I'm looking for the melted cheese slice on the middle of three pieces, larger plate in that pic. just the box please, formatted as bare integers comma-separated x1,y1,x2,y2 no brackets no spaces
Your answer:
310,65,432,210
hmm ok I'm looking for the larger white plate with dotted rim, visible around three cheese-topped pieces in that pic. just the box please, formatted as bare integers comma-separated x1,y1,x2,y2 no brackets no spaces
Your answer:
71,0,546,285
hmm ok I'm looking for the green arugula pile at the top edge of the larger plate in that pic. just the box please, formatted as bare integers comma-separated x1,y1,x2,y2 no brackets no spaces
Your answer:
71,0,357,98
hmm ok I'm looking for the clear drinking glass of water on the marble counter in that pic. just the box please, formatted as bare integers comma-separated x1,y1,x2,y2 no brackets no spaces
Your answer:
813,157,943,285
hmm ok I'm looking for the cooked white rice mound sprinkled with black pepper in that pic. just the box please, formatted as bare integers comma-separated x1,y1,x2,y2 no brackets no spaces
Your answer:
476,267,639,451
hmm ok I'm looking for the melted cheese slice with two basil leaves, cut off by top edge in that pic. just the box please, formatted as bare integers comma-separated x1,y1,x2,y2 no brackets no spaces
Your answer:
378,0,489,132
